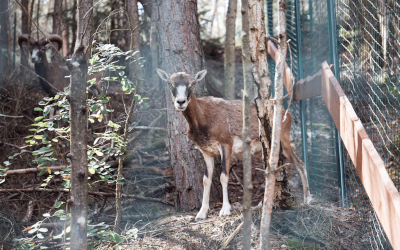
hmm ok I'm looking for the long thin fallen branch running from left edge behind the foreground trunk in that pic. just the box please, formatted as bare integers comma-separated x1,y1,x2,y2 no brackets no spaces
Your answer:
0,187,174,206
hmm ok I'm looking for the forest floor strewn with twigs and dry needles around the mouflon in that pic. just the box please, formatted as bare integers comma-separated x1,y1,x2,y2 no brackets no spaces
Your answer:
0,48,369,250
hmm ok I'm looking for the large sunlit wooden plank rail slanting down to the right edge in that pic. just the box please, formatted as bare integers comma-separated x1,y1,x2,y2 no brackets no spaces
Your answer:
321,62,400,249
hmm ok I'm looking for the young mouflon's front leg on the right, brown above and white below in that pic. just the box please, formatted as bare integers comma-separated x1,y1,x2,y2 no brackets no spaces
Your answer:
219,146,232,216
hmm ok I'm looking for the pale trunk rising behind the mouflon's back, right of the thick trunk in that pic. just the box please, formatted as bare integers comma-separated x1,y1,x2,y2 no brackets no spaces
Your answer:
224,0,237,100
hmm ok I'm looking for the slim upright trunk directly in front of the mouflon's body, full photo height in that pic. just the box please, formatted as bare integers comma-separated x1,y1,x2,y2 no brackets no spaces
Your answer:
242,0,253,246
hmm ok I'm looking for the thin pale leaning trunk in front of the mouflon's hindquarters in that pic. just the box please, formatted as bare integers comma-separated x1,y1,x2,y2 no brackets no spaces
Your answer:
260,0,287,249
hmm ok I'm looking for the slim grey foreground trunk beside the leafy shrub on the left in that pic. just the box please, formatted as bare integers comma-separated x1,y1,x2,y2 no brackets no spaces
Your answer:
68,0,93,247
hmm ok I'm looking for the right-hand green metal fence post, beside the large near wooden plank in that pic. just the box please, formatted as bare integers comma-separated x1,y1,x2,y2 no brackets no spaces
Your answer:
327,0,347,207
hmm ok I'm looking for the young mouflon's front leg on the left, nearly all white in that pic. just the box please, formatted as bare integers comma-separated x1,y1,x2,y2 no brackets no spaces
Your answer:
196,151,214,220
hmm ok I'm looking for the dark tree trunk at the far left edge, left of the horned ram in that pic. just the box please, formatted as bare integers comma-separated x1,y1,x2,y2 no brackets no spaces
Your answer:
0,0,11,76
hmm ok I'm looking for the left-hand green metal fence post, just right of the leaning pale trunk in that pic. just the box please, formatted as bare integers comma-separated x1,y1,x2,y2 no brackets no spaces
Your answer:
295,0,310,185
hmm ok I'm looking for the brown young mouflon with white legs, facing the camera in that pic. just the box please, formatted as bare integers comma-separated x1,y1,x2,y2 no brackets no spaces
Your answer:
157,69,311,220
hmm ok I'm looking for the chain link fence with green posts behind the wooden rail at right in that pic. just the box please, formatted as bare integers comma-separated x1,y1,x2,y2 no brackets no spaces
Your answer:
266,0,400,249
